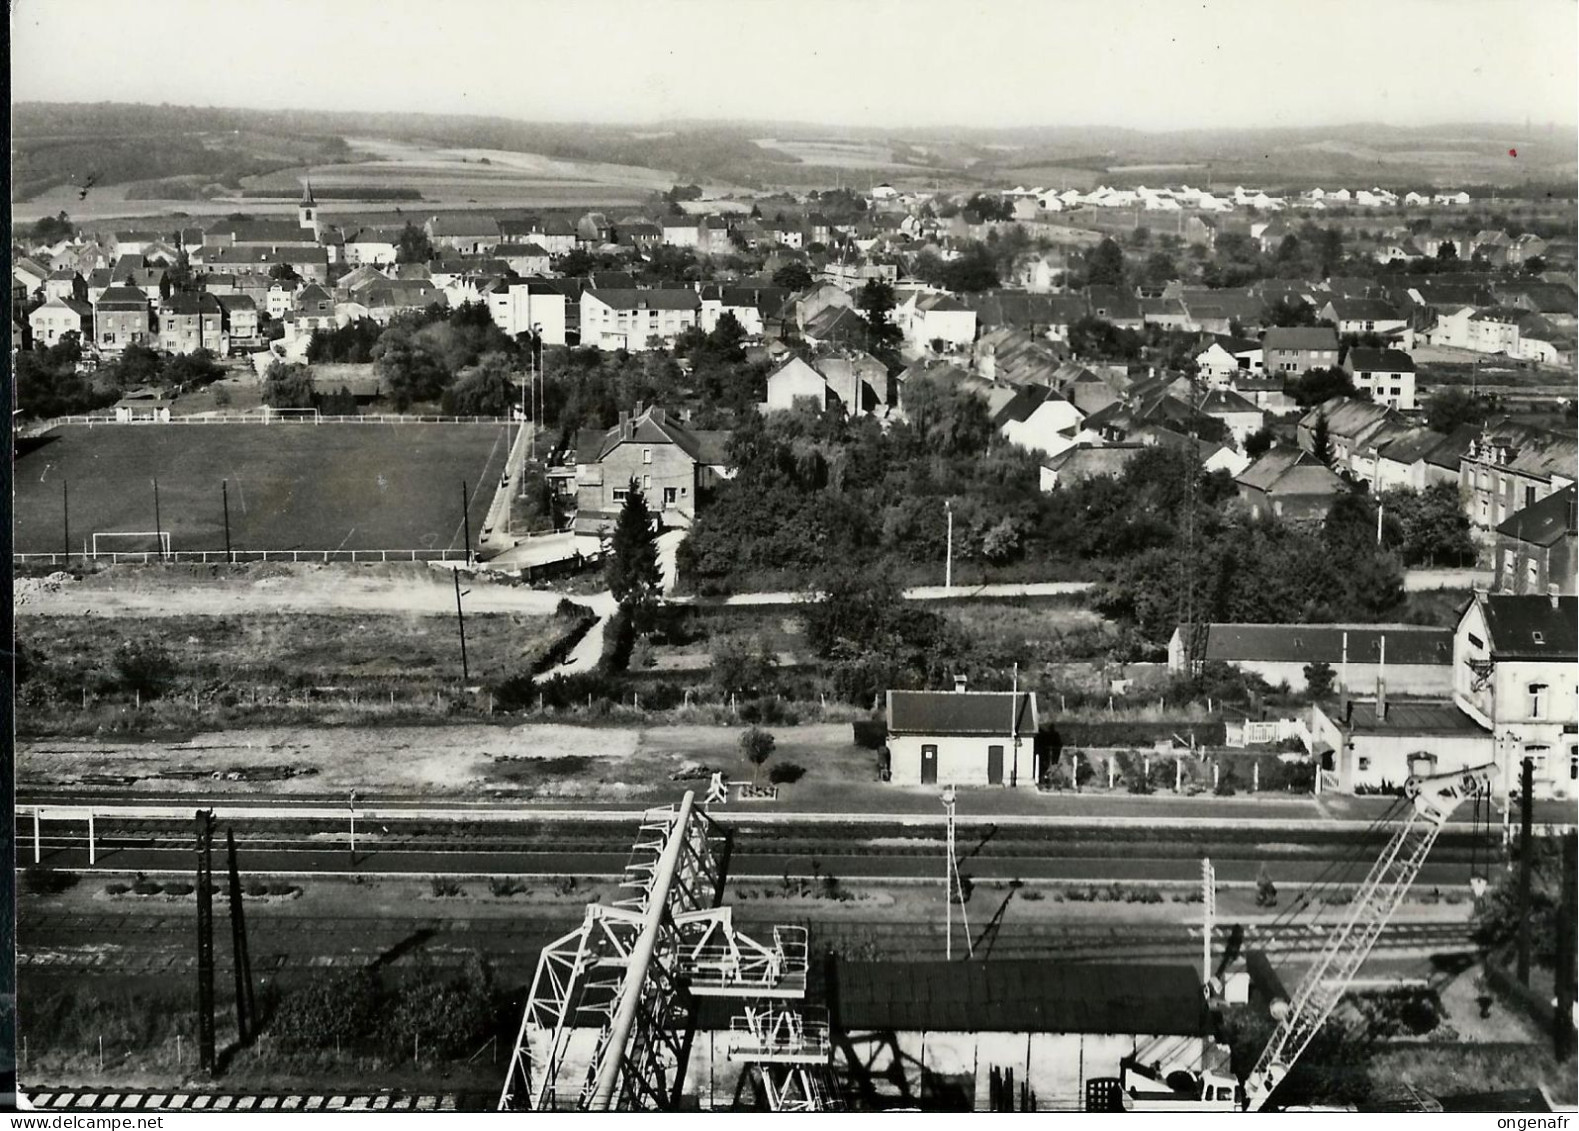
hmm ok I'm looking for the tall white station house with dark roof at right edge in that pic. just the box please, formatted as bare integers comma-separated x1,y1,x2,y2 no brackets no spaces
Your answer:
1453,592,1579,798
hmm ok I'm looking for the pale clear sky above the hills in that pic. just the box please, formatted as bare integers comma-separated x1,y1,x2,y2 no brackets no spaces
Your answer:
11,0,1579,130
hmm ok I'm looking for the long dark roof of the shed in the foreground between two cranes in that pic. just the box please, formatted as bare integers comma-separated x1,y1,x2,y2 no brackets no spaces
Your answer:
829,959,1211,1036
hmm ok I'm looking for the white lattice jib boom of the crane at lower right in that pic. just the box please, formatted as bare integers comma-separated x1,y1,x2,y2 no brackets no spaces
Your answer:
1244,766,1491,1112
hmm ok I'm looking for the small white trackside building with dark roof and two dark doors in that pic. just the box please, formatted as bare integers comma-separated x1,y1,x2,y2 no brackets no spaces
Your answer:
887,679,1039,787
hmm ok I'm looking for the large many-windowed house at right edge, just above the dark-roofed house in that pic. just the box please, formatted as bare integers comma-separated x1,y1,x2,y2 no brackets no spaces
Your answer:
1459,420,1579,540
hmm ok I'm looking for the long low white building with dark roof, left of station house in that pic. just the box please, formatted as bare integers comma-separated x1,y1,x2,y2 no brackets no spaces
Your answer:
1168,624,1453,695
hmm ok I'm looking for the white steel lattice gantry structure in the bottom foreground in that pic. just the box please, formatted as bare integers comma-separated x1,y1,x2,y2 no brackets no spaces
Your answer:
499,793,829,1112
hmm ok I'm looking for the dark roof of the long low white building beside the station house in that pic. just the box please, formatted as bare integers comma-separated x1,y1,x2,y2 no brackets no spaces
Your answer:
1205,622,1446,667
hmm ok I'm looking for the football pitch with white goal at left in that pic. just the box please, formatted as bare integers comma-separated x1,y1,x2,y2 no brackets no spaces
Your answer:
13,423,505,553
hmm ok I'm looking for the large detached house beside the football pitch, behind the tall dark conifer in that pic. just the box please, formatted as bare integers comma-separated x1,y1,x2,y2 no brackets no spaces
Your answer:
576,408,733,534
